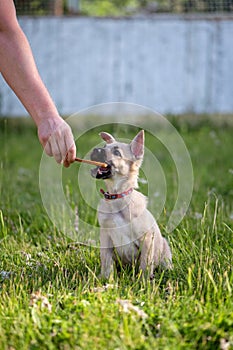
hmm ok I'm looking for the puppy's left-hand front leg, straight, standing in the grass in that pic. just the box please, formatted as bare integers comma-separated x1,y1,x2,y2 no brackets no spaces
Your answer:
100,229,113,279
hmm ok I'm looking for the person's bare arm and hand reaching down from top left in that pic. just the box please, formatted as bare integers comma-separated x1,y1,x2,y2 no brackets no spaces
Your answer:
0,0,76,166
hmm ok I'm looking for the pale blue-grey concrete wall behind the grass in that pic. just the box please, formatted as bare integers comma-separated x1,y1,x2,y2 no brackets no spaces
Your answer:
0,15,233,115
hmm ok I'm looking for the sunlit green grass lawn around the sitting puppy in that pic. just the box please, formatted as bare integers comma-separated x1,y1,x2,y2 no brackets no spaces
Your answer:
0,118,233,350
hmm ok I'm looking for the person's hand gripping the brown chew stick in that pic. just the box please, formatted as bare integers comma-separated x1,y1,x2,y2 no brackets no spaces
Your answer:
38,117,76,167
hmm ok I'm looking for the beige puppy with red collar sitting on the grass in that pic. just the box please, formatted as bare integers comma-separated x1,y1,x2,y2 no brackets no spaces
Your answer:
91,130,172,278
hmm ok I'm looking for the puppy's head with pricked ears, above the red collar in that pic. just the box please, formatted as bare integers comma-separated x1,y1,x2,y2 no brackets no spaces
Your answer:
91,130,144,187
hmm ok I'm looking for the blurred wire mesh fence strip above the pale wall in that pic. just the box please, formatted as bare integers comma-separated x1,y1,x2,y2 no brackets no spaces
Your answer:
14,0,233,16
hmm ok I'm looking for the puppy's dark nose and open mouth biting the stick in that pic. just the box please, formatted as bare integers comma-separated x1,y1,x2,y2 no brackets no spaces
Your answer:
91,148,112,180
